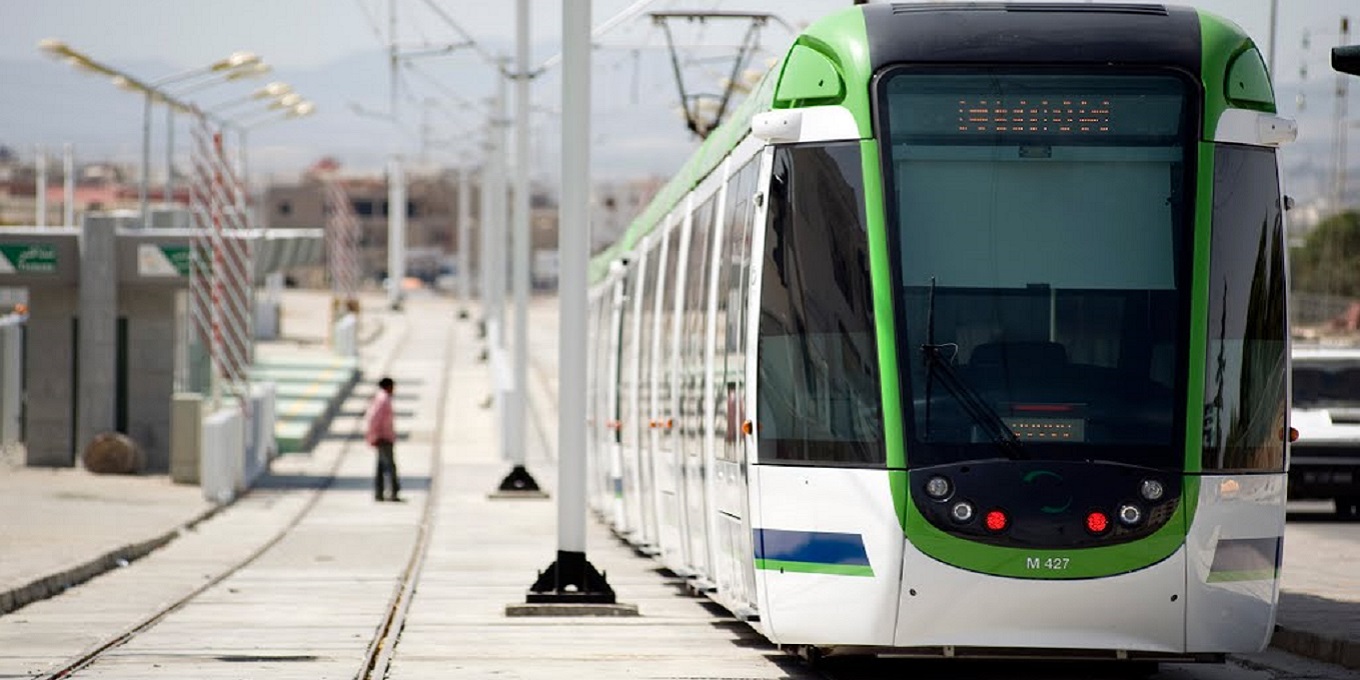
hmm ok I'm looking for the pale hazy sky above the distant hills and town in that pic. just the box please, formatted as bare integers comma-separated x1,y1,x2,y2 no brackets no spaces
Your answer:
0,0,1360,198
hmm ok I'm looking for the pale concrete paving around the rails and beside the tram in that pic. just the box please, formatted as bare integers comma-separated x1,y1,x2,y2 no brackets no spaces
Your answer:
0,289,1360,677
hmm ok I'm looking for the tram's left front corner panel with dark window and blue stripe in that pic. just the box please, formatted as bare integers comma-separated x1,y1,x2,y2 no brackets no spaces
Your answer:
747,140,902,645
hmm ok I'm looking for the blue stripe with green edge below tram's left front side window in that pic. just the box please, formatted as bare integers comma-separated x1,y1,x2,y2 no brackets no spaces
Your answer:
753,529,873,577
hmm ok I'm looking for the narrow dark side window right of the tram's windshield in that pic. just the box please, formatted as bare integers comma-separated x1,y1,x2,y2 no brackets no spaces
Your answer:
1204,144,1289,471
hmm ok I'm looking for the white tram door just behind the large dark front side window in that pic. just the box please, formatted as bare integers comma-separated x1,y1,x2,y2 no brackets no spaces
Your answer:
711,156,760,616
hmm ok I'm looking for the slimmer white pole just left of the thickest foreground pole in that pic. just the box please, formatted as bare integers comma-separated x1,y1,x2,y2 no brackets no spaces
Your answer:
506,0,530,466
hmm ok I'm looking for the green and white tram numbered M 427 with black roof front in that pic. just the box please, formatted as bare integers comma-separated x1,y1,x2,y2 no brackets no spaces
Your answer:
590,3,1295,661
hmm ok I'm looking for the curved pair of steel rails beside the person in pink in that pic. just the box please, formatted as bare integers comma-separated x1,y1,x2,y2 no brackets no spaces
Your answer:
41,310,457,680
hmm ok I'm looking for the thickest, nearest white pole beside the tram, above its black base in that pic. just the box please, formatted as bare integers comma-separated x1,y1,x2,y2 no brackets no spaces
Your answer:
558,0,590,554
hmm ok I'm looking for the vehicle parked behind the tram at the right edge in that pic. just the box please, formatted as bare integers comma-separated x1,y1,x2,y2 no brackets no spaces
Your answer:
1289,347,1360,518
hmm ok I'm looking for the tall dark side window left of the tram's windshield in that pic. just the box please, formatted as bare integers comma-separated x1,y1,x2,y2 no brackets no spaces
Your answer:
756,143,884,465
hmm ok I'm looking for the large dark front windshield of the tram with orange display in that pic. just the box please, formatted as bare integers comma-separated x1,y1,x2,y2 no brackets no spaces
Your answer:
879,68,1194,468
